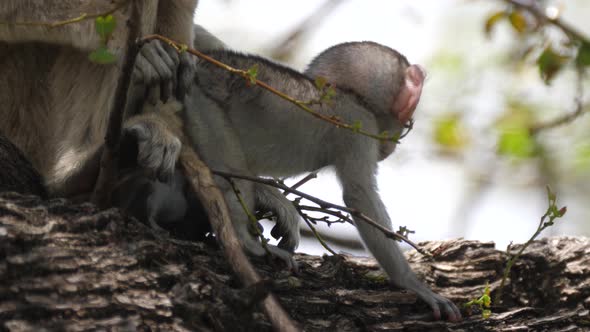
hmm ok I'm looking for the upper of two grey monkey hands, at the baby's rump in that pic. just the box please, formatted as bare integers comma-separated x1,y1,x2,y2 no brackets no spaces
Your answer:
132,40,195,105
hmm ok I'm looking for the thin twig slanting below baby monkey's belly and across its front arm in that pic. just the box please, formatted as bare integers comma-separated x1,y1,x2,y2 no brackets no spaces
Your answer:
211,170,432,257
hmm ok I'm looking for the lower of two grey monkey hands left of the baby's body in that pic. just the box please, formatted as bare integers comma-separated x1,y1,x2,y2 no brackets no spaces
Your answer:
121,115,182,182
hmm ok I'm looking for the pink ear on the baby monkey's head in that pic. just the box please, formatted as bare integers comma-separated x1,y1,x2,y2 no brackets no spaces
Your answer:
392,65,426,124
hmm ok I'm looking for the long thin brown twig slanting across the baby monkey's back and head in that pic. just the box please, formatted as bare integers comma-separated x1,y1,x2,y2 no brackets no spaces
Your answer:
142,34,399,144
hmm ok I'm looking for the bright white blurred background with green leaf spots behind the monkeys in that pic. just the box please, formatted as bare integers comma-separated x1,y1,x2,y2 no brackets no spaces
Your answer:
195,0,590,254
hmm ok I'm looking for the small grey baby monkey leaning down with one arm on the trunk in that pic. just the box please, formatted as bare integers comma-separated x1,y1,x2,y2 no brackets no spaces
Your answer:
120,42,461,321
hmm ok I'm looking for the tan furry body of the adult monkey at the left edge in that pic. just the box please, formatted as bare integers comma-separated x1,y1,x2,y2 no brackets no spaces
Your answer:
0,0,197,196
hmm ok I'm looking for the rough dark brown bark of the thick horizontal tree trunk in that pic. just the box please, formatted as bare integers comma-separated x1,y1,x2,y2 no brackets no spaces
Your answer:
0,194,590,331
